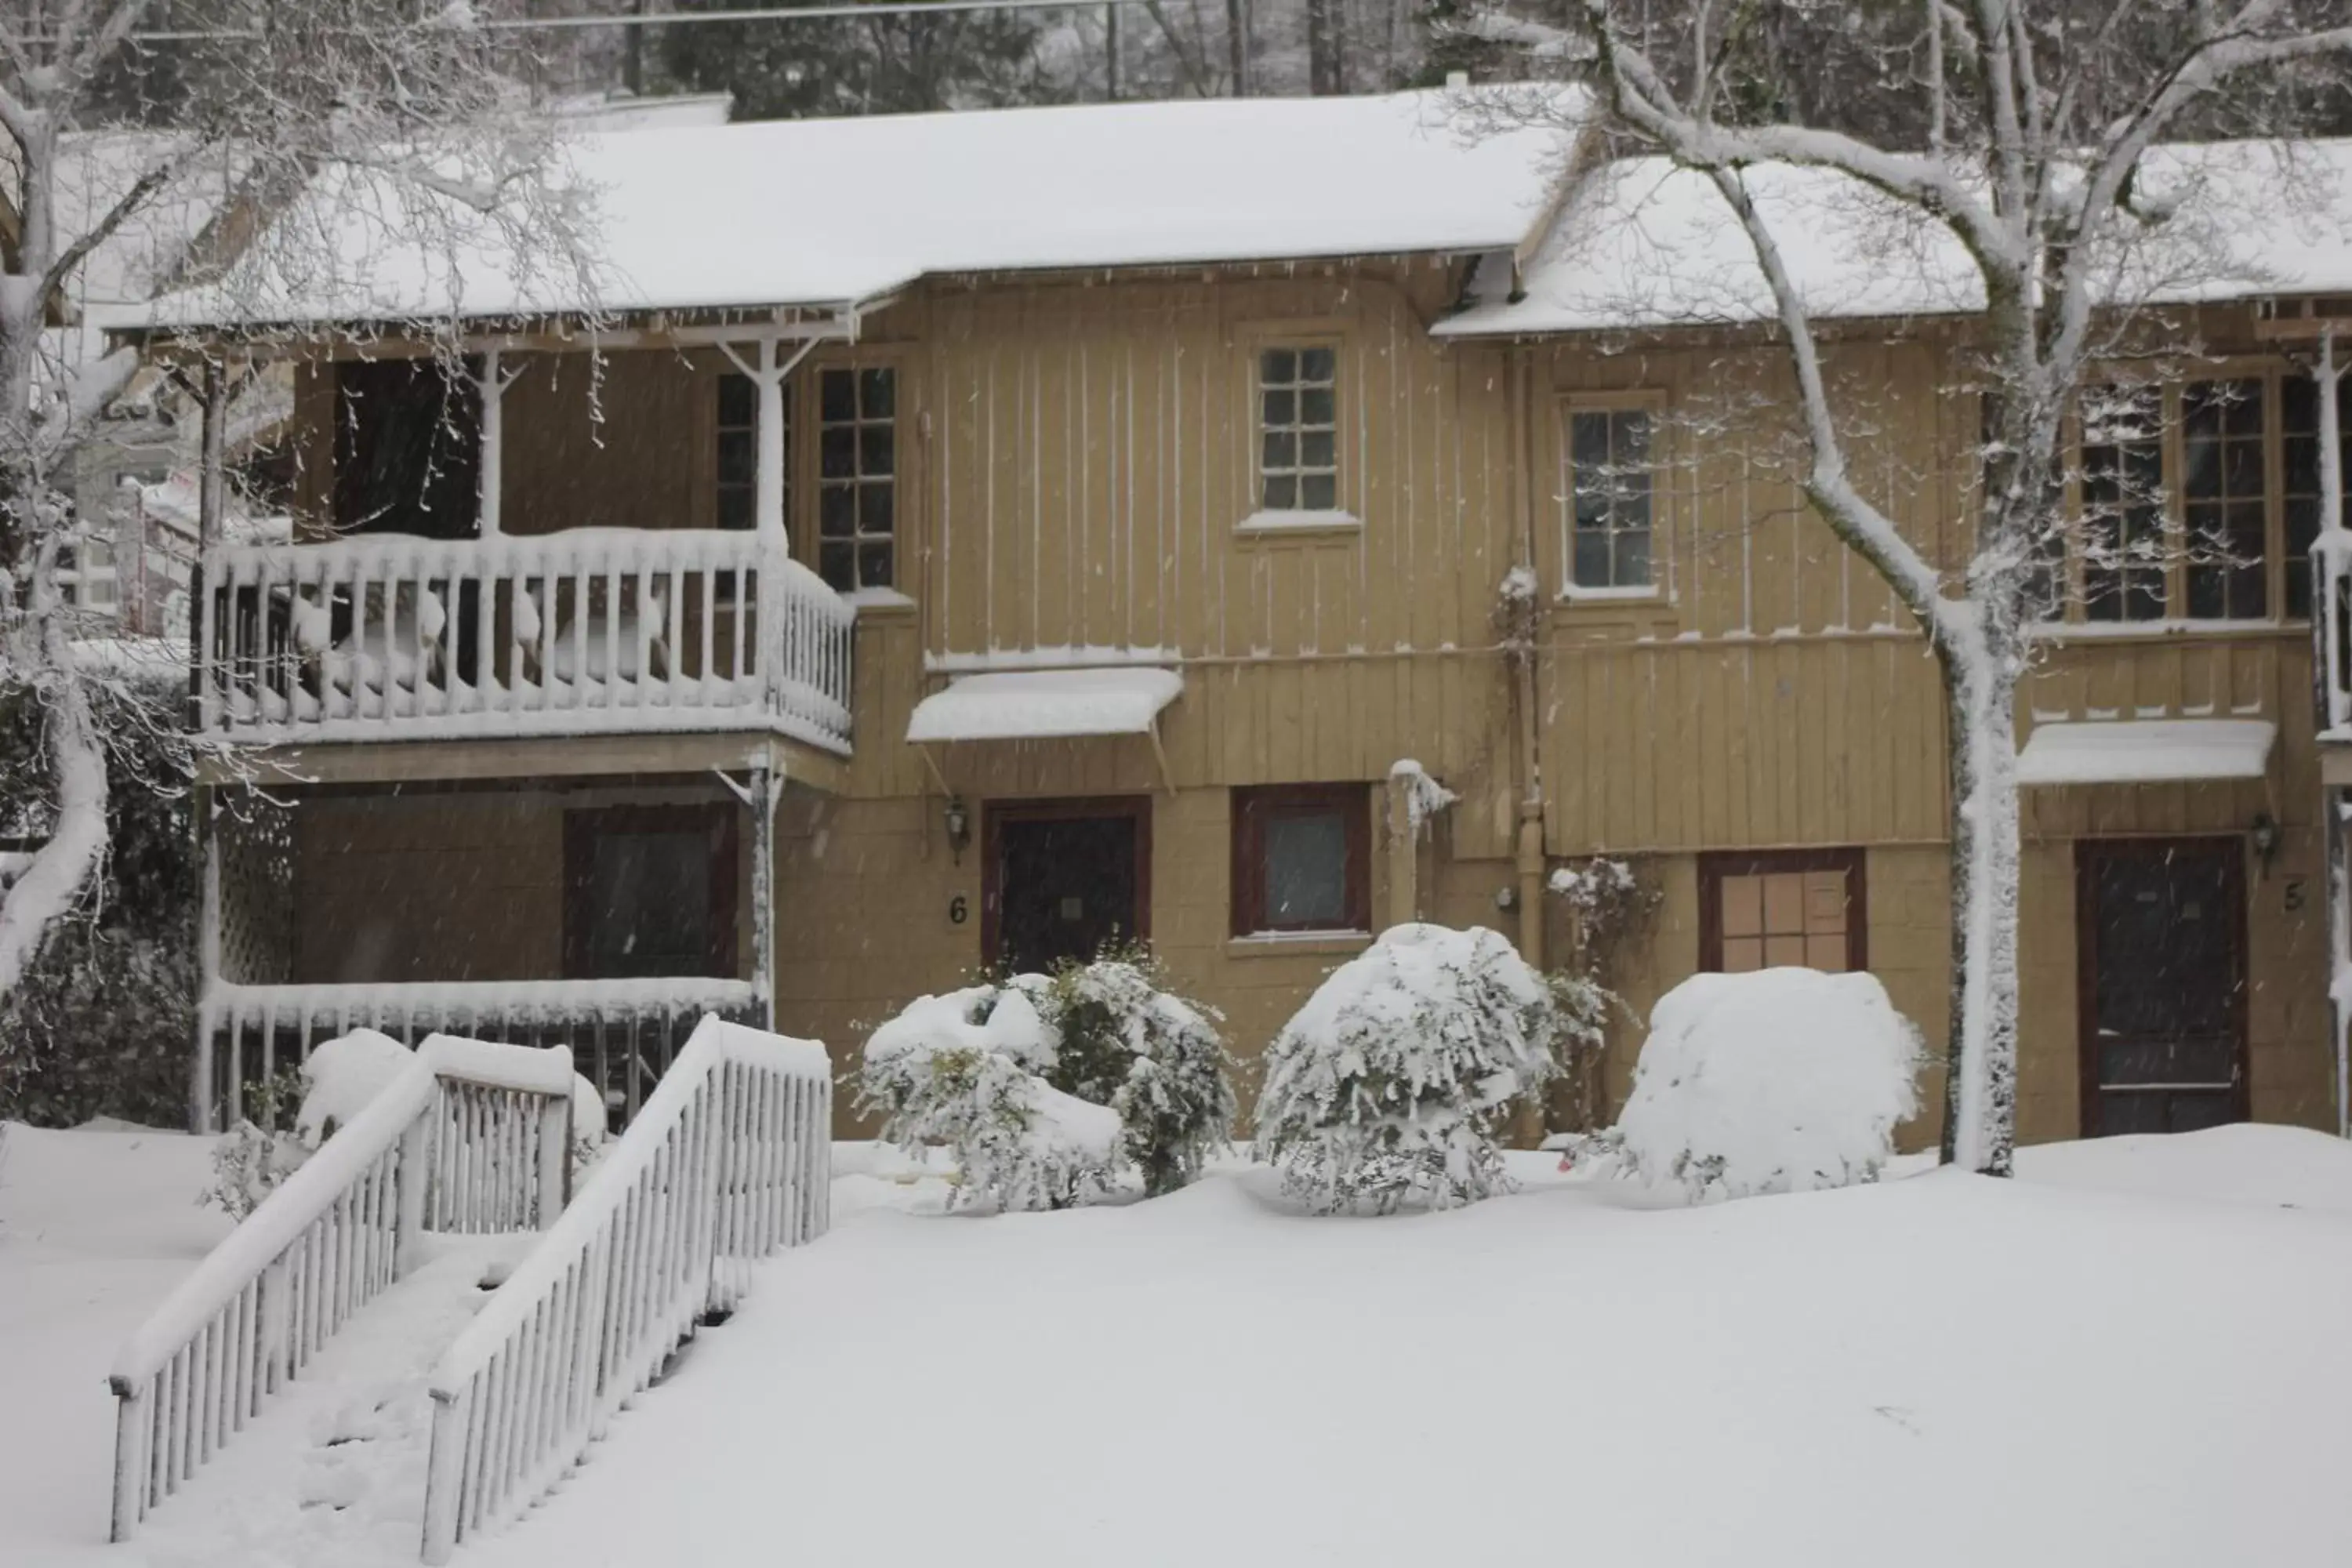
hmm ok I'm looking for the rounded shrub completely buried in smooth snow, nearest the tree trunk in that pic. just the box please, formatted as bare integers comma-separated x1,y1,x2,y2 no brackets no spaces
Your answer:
1616,968,1919,1196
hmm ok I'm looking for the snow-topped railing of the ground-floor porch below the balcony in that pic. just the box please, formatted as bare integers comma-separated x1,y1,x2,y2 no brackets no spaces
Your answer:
198,975,760,1126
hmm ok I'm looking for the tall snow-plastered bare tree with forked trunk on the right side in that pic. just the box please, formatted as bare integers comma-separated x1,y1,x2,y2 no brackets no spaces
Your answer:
1489,0,2352,1175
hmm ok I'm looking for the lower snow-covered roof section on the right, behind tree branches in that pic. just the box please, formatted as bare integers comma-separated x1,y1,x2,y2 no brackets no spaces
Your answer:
1437,139,2352,336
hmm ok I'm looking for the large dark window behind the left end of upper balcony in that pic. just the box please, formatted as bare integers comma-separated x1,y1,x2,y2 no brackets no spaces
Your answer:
334,360,482,539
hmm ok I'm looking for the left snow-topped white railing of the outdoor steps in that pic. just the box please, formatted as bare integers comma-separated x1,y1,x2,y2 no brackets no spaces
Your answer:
111,1036,572,1540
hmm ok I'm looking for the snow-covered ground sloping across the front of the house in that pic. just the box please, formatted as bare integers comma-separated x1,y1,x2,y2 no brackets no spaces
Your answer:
0,1128,2352,1568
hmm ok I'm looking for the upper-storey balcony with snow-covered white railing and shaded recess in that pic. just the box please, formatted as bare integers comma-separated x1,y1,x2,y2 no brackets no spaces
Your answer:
191,329,866,757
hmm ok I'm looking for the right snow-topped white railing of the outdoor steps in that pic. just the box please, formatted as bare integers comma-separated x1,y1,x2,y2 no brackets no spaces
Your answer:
423,1018,833,1563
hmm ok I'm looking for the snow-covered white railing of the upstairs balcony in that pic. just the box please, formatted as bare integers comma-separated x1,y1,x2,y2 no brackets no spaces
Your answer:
195,529,854,753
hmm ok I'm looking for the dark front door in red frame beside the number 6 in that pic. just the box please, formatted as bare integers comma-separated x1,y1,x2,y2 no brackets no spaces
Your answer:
983,797,1152,973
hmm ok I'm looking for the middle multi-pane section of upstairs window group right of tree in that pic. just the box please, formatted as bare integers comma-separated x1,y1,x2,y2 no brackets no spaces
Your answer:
2180,379,2270,621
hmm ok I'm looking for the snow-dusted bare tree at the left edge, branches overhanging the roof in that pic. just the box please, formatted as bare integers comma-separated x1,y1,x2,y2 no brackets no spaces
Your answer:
0,0,593,994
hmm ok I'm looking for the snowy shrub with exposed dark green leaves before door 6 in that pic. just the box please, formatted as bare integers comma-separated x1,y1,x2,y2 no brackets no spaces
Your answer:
858,954,1235,1208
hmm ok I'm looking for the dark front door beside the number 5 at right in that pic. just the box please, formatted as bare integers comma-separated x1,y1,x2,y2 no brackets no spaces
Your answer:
2077,839,2246,1138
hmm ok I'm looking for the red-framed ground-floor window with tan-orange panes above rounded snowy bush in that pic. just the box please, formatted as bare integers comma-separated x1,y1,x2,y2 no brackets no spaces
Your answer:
1698,848,1870,973
